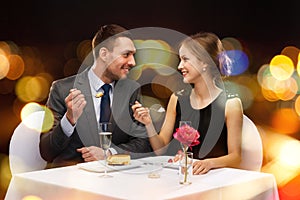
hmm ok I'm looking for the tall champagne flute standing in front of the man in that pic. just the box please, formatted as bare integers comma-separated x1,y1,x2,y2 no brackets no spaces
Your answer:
99,122,112,178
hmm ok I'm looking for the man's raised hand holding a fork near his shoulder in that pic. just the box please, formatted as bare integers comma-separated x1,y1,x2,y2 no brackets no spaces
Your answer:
65,89,86,126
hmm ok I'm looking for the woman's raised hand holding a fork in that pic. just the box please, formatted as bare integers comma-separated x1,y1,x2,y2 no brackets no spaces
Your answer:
131,101,152,125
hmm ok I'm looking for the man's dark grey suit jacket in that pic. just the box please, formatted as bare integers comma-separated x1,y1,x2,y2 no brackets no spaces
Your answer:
40,69,152,167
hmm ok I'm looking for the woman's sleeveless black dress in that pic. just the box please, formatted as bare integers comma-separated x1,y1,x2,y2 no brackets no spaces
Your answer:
166,90,228,159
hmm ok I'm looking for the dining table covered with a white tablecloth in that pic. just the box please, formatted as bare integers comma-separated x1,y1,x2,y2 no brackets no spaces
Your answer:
5,156,279,200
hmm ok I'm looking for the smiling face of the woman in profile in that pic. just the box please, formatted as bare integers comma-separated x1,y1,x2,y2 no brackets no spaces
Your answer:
178,45,207,83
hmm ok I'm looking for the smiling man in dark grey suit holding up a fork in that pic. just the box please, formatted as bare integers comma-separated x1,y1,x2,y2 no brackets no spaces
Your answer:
40,24,151,167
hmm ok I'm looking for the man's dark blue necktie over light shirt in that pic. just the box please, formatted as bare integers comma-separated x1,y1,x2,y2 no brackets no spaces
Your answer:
100,84,111,122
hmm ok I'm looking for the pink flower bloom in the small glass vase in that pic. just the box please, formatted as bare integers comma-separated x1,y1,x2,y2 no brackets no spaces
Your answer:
173,125,200,147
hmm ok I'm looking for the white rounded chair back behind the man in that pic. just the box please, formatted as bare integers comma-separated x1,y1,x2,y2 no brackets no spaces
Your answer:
9,111,47,175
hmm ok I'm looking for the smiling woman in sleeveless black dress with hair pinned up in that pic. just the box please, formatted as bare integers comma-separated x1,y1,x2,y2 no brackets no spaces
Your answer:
132,33,243,174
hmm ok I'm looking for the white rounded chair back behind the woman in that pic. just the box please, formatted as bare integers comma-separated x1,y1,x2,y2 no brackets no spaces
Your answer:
241,115,263,171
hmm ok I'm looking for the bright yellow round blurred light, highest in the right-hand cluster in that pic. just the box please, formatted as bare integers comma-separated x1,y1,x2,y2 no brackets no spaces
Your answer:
270,55,294,80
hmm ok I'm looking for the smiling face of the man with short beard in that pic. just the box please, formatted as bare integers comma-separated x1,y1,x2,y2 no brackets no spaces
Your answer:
104,37,136,81
